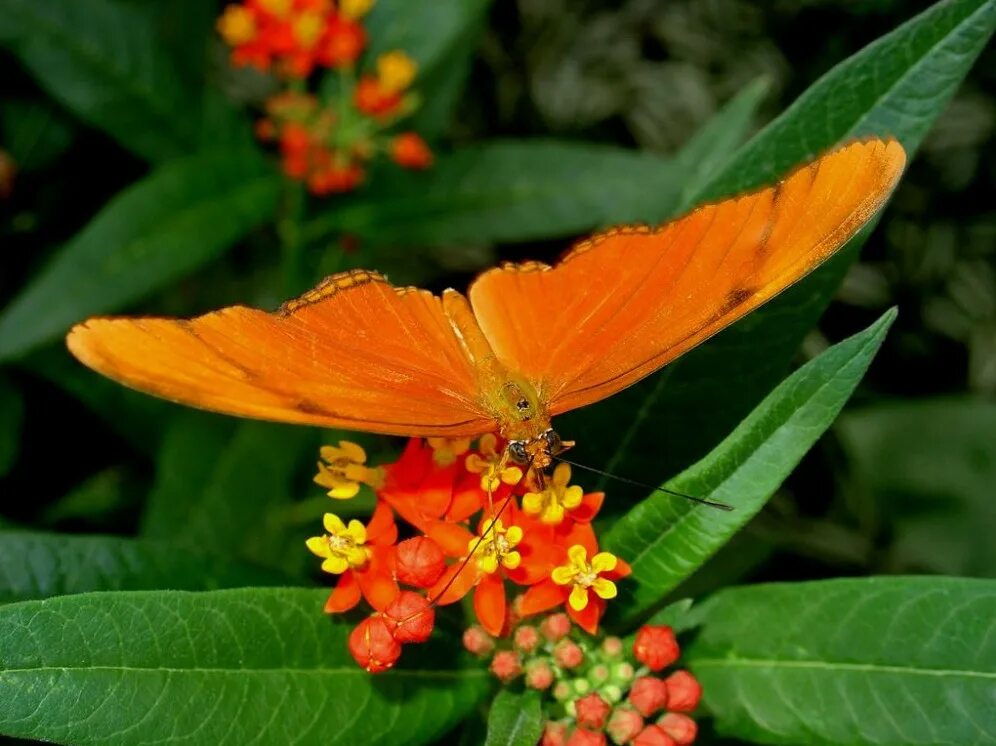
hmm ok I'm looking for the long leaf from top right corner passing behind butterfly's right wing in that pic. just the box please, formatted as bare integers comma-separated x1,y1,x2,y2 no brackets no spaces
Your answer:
560,0,996,487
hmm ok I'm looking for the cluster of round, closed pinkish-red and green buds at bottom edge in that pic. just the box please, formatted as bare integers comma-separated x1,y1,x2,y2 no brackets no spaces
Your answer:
464,613,702,746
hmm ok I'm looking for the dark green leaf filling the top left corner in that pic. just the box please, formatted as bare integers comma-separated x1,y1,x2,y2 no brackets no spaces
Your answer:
0,0,197,161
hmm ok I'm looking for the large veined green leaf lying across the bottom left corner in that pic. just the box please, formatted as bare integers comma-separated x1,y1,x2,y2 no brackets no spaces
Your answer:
0,589,490,746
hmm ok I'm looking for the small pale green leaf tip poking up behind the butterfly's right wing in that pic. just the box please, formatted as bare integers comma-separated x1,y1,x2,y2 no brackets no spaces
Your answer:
673,78,768,212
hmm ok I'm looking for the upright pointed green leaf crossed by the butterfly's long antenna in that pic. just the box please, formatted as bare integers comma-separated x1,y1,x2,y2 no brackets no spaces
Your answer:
604,310,896,620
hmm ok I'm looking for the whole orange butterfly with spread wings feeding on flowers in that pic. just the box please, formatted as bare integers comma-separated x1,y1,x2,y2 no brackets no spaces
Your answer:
67,140,906,467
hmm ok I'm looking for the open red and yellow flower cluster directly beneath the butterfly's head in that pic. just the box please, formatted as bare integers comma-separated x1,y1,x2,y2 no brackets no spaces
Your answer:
307,435,629,671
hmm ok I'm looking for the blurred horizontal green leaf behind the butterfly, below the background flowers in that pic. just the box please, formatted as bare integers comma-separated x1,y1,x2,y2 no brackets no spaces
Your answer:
305,140,679,246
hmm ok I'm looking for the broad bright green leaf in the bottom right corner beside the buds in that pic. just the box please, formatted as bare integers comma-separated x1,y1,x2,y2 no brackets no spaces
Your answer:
685,577,996,745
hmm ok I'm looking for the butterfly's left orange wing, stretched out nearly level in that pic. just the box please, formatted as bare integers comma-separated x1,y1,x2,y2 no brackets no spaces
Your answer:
67,270,494,437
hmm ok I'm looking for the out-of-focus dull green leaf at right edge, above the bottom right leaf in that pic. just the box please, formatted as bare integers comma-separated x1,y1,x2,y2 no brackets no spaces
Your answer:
835,397,996,577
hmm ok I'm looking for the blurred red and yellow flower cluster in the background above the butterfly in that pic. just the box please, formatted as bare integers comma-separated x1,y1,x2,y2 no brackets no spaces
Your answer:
218,0,433,196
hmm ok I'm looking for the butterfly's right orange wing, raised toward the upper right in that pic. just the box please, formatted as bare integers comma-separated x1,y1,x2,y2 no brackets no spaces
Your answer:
469,140,906,414
